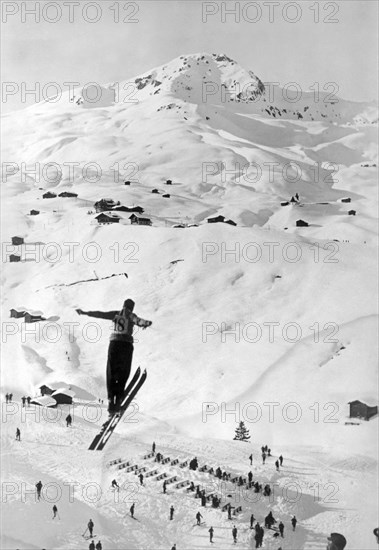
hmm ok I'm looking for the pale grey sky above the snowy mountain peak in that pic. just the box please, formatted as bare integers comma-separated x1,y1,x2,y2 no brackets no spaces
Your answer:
1,0,378,112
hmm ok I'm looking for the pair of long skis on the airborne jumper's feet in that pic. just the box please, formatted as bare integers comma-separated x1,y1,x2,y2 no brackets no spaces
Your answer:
88,367,147,451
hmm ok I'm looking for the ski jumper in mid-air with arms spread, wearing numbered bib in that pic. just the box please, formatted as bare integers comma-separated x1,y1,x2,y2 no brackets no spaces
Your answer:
76,299,152,414
